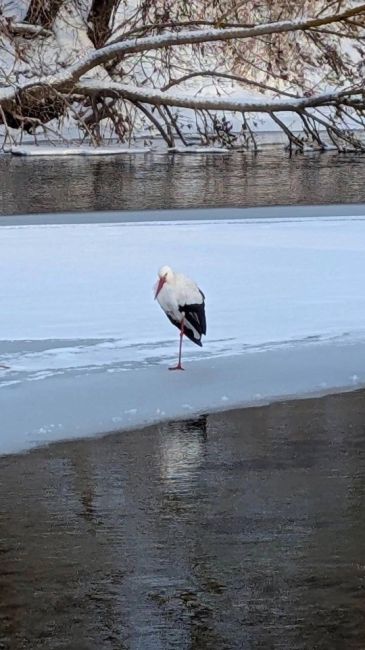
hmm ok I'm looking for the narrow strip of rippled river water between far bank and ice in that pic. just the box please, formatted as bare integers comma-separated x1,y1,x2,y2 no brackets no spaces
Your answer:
0,147,365,215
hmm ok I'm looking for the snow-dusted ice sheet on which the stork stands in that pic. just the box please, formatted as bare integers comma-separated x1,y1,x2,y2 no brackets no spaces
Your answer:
0,208,365,453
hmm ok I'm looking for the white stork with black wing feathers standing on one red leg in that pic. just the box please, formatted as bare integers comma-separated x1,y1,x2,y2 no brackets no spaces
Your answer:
155,266,207,370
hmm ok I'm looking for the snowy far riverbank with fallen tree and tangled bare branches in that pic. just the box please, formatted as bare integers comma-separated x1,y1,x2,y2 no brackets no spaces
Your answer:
0,0,365,147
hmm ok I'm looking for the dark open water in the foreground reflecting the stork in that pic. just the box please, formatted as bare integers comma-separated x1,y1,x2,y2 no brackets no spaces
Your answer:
0,392,365,650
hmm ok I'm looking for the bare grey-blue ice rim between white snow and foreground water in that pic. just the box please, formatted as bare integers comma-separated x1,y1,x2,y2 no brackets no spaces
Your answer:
0,337,365,454
